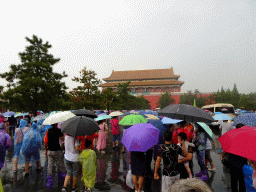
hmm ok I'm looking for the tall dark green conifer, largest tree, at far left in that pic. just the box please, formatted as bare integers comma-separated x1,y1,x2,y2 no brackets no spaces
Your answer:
0,35,67,115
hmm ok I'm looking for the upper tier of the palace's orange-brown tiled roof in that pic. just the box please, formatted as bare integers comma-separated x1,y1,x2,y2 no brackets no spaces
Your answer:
103,68,180,81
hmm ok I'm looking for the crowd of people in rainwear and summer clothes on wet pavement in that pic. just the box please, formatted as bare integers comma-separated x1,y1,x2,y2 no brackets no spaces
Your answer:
0,111,256,192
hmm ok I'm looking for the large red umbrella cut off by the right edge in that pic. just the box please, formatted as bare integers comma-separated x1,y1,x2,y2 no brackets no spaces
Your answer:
219,126,256,161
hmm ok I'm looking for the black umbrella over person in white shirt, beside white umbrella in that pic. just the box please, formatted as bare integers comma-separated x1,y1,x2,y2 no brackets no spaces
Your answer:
61,116,100,137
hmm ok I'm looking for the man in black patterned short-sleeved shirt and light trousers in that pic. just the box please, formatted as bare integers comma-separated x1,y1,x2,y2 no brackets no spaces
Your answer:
154,131,187,192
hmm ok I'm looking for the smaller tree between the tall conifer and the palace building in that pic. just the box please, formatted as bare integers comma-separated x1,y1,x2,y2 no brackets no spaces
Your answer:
70,67,100,109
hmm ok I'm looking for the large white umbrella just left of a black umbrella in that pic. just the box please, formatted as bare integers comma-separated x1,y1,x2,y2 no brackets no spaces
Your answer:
43,111,75,125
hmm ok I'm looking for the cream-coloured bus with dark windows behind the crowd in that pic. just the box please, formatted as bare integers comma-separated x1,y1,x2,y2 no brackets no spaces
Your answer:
202,103,236,118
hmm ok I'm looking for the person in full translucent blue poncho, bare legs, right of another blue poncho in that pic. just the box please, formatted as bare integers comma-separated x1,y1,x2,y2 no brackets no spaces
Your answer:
21,123,42,176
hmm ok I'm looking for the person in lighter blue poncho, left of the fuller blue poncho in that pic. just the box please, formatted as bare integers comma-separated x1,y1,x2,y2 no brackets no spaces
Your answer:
14,119,29,173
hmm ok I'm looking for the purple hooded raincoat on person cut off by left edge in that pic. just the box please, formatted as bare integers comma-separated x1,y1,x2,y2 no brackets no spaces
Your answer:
0,123,12,169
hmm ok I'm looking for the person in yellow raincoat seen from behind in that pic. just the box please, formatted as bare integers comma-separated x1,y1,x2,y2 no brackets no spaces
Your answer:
78,139,97,191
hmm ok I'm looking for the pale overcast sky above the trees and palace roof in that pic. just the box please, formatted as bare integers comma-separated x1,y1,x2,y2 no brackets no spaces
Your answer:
0,0,256,93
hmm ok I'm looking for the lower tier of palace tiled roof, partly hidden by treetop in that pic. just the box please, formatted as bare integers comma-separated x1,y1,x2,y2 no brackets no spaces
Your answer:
99,80,184,87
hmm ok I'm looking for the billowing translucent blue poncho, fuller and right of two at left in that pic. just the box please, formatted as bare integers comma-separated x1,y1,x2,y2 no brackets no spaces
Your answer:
21,123,42,161
